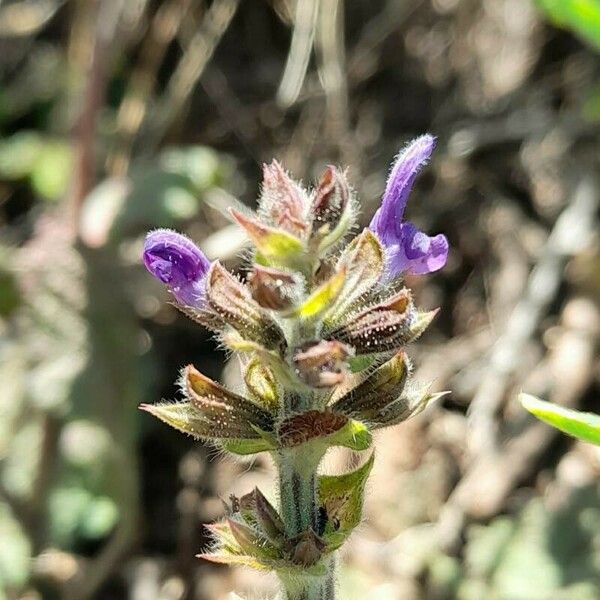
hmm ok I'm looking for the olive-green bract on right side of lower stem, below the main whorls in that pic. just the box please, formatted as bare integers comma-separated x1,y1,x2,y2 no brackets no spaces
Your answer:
318,454,375,551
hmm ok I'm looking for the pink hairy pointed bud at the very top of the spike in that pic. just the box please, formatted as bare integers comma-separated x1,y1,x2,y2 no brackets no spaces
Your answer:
260,160,308,237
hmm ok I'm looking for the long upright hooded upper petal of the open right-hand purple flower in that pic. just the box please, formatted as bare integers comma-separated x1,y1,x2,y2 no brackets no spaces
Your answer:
369,134,436,244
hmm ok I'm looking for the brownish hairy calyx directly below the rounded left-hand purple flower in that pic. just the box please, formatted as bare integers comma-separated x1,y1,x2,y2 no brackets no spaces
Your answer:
206,261,286,350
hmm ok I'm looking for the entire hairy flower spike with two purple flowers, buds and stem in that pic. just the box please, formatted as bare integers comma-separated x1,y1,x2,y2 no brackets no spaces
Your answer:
141,146,448,600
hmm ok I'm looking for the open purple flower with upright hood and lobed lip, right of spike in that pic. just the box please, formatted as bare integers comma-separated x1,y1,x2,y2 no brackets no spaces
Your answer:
369,134,448,279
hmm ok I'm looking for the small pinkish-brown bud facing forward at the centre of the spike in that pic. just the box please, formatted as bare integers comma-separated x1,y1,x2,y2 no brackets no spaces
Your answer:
293,340,353,388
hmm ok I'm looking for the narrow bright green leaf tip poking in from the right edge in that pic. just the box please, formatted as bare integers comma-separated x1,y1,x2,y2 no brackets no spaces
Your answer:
519,394,600,446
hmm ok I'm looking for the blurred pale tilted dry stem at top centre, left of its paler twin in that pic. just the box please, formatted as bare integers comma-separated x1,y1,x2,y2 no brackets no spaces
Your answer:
277,0,319,107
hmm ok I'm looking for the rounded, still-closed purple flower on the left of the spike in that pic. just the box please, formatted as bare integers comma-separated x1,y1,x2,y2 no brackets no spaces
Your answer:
143,229,211,307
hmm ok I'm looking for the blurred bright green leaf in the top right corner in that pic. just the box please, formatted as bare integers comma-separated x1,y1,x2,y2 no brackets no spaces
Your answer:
537,0,600,49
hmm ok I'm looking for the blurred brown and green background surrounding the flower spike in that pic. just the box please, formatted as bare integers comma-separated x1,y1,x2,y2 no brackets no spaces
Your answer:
0,0,600,600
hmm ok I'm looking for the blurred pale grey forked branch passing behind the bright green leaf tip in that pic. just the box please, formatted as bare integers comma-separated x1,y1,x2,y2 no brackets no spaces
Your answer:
437,177,599,549
